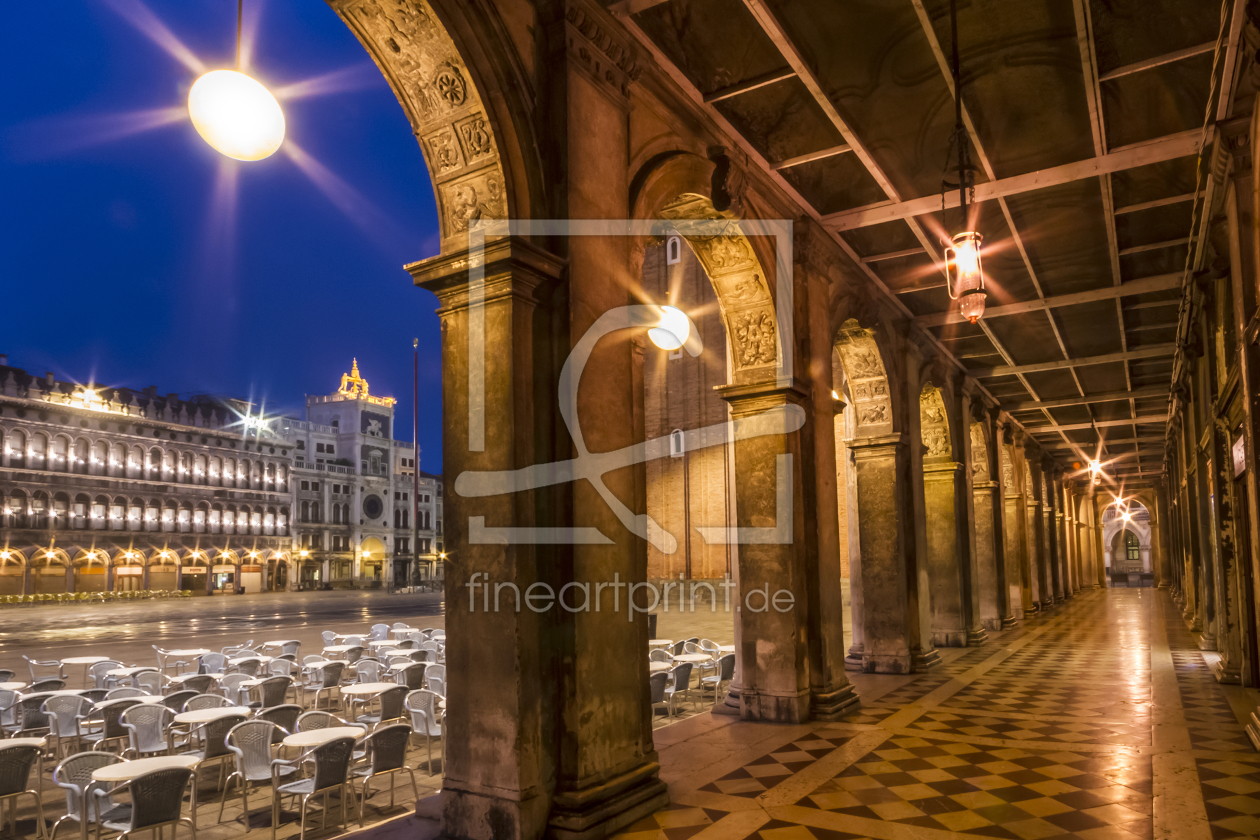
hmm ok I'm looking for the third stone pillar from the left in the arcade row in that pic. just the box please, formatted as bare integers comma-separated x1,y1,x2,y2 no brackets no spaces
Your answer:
849,434,914,674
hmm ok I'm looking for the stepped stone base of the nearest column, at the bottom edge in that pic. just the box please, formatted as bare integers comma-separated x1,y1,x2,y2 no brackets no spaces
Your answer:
549,762,669,840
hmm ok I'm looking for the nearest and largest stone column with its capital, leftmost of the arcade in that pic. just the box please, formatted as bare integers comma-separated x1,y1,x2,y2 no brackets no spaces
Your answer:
408,238,567,840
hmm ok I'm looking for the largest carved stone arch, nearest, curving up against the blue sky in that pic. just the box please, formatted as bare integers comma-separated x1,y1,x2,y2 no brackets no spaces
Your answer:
329,0,542,253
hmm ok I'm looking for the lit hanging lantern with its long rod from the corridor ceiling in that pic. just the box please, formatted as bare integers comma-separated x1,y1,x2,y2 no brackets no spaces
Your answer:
941,0,985,324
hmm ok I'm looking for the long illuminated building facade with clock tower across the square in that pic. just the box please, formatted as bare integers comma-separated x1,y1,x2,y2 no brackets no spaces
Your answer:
0,356,441,596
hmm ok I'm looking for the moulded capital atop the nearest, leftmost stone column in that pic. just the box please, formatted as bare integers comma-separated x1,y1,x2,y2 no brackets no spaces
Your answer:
406,237,566,315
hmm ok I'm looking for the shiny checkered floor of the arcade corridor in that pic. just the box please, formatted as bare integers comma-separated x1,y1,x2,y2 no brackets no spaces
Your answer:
609,589,1260,840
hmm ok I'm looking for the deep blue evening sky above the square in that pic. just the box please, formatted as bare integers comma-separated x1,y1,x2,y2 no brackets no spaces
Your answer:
0,0,441,471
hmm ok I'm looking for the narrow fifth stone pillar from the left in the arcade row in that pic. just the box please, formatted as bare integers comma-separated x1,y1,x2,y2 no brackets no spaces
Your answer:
970,402,1007,630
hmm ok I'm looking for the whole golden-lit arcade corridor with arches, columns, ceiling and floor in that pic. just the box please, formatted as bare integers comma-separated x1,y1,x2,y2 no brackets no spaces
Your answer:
329,0,1260,840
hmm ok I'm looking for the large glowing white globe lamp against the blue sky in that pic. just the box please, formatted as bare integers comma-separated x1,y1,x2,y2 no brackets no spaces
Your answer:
188,71,285,161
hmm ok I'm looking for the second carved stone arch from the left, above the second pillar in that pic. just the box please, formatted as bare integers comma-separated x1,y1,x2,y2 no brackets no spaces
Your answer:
630,151,790,383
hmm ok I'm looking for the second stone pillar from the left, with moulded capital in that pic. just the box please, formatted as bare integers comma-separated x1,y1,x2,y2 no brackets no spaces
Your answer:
719,385,821,723
